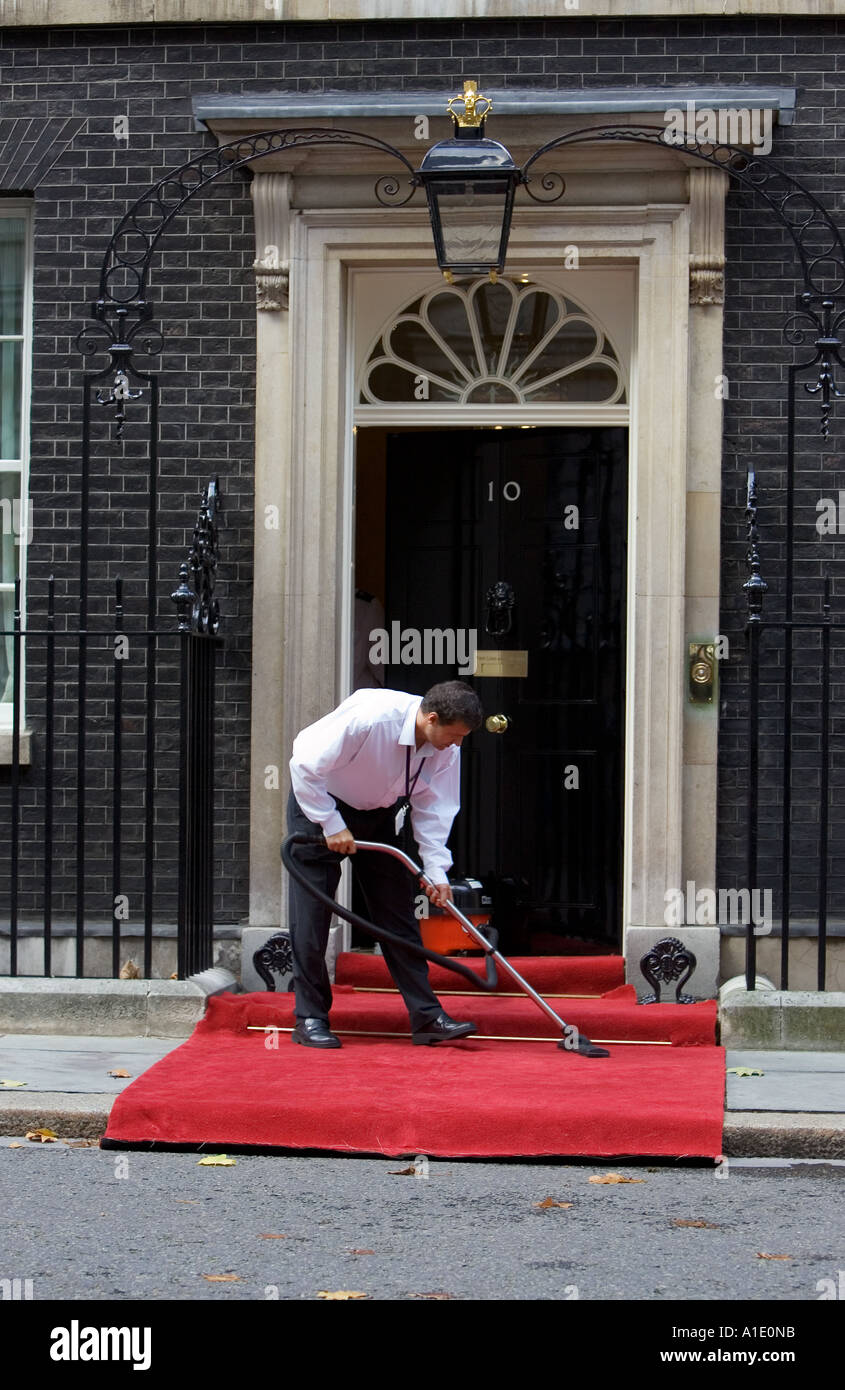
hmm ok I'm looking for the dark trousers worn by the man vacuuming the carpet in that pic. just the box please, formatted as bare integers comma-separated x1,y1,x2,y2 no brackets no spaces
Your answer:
288,792,441,1029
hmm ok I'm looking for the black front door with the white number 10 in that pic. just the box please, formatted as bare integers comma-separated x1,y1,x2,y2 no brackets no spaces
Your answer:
385,427,627,954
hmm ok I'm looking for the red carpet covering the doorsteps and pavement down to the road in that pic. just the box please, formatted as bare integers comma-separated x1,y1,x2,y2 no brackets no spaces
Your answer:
103,955,724,1158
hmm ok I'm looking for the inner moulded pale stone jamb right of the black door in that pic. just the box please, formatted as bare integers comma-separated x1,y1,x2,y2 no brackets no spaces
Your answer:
624,207,689,956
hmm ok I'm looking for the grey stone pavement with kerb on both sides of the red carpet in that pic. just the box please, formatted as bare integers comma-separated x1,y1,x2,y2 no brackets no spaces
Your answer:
0,1033,845,1159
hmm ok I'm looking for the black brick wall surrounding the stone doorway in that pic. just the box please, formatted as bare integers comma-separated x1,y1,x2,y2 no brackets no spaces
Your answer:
0,17,845,920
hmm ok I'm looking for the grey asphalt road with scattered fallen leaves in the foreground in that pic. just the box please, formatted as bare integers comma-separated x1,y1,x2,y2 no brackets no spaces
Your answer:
0,1138,845,1301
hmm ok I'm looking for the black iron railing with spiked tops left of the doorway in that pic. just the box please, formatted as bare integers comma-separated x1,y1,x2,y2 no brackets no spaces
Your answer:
0,478,222,979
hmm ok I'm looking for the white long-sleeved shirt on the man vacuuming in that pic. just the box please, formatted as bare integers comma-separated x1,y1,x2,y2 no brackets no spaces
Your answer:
290,689,460,883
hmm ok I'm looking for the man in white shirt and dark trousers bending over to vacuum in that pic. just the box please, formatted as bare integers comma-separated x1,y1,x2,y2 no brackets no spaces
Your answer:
288,681,482,1048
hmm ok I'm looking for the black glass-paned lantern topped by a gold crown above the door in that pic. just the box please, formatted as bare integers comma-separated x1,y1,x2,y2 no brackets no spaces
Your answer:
418,82,521,279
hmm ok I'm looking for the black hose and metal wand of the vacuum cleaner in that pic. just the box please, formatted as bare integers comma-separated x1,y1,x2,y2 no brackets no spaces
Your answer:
282,831,610,1056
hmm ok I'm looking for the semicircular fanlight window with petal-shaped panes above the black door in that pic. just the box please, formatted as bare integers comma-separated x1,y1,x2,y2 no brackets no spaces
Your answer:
360,278,625,406
